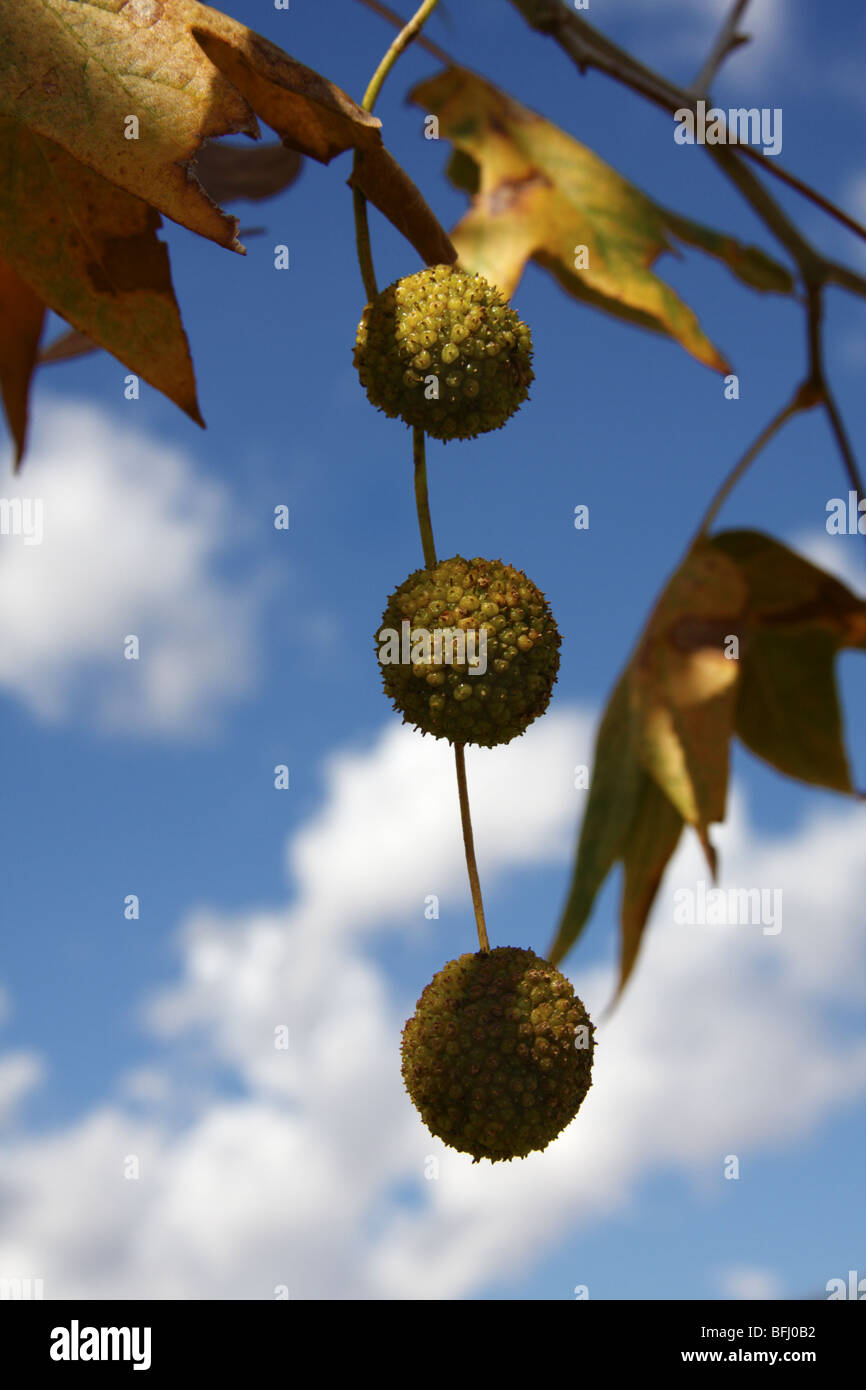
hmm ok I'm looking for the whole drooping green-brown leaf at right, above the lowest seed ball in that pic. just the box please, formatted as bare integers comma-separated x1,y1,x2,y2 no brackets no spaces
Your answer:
548,531,866,994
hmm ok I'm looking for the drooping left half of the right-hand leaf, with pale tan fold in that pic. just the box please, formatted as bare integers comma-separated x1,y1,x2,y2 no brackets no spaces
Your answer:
550,543,748,991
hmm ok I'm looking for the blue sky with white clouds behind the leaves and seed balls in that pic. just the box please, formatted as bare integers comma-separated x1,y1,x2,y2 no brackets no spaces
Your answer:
0,0,866,1300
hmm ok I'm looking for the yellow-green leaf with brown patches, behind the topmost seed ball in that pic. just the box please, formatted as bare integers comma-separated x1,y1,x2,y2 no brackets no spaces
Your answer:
411,68,792,371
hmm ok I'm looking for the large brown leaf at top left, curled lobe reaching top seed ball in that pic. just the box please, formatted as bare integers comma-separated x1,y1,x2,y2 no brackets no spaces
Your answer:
0,0,456,461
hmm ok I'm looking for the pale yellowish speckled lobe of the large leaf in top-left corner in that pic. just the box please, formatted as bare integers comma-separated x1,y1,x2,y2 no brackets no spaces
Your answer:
0,0,259,249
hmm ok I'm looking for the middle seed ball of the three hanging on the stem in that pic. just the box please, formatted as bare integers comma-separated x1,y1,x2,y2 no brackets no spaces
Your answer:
377,555,560,748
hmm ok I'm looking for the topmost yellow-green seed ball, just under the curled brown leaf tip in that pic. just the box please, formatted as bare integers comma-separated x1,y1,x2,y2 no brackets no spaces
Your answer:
354,265,534,439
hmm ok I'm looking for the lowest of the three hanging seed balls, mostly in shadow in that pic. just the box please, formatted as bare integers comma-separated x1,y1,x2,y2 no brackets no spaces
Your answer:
403,947,594,1162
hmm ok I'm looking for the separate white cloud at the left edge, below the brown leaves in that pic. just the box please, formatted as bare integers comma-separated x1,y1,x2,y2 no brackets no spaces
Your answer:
0,402,261,733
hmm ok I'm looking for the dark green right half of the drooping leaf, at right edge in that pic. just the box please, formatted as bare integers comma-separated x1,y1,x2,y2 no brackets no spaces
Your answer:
712,531,866,792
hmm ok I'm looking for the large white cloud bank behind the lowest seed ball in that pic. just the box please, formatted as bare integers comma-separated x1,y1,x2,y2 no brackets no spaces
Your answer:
0,709,866,1298
